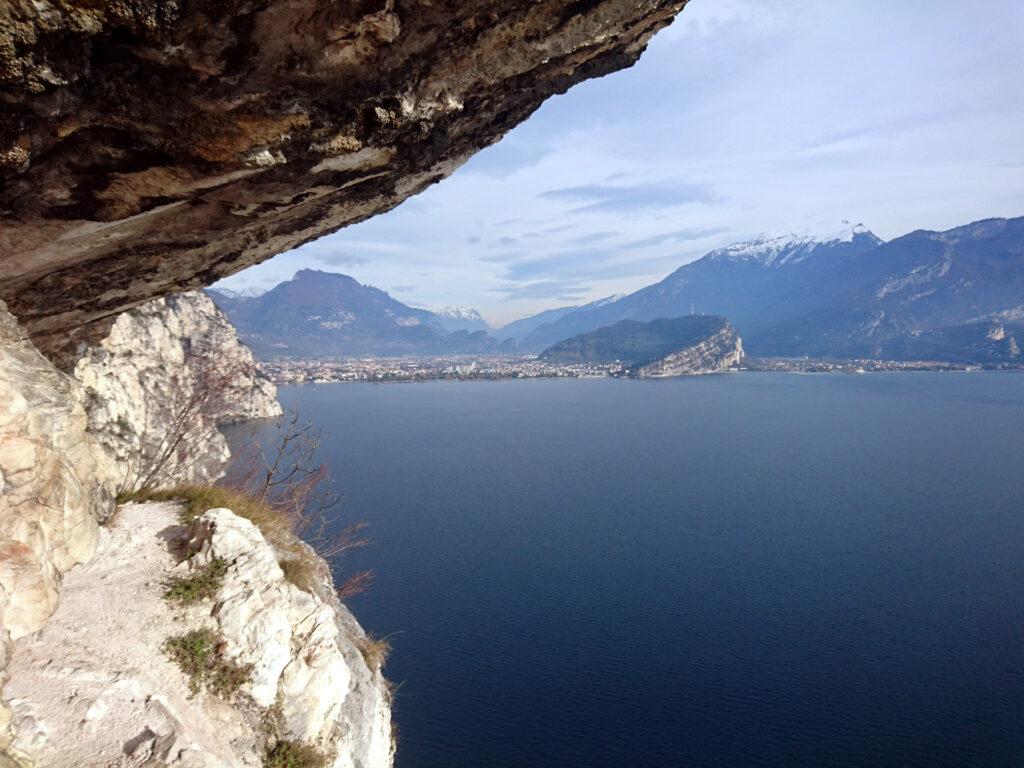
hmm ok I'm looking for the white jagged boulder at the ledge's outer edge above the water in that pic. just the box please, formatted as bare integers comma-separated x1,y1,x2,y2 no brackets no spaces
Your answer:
188,509,391,768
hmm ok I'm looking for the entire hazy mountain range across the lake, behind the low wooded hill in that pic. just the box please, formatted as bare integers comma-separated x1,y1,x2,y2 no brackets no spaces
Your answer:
210,217,1024,362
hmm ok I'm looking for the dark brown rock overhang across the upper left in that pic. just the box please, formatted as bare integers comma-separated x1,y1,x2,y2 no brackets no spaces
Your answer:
0,0,686,365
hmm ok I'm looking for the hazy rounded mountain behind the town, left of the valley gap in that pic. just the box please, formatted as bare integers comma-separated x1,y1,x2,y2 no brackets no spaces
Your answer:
209,269,511,359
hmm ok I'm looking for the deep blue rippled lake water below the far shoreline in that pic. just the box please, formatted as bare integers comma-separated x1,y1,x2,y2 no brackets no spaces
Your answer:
249,373,1024,768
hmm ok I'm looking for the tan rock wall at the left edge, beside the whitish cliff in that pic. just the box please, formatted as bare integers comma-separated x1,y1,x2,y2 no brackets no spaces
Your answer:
0,302,114,764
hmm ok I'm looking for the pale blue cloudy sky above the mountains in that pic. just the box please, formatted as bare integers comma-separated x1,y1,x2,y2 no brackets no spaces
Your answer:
214,0,1024,325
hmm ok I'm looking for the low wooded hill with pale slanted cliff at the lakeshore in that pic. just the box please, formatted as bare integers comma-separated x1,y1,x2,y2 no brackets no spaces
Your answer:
540,314,742,376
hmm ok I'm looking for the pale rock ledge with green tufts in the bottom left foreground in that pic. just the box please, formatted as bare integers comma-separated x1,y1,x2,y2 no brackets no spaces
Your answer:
5,504,392,768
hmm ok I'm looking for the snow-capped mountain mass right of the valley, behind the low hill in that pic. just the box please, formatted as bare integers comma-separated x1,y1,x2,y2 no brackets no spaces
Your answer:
520,218,1024,361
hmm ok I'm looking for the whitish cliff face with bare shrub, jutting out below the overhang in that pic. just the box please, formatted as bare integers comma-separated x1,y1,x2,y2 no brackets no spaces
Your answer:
74,291,281,488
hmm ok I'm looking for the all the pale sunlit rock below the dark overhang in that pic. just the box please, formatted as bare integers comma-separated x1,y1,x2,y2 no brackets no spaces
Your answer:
0,293,393,768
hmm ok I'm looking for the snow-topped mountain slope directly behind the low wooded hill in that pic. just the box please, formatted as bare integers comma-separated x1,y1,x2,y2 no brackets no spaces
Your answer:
520,226,882,351
